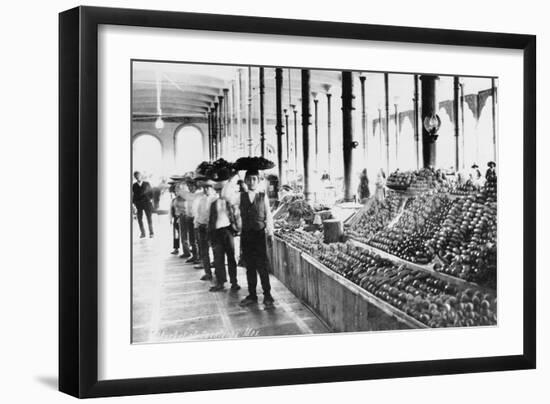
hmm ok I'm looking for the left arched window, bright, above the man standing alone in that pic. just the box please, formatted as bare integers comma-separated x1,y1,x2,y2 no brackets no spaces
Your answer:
132,133,164,182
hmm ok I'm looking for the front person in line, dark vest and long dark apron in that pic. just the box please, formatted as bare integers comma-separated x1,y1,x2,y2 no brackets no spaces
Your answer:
239,170,274,308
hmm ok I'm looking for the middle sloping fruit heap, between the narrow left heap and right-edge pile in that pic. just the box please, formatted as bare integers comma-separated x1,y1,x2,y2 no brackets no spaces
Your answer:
368,193,452,264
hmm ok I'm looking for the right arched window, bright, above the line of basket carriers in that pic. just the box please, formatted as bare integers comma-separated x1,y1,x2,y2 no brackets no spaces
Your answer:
175,126,205,174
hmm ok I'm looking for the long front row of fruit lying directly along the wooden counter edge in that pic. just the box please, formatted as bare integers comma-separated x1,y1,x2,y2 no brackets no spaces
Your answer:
314,243,497,328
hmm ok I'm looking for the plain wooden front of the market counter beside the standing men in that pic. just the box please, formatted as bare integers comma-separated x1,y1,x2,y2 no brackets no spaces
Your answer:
271,237,427,332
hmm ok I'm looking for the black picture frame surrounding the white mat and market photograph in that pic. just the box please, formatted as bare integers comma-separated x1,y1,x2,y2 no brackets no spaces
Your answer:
59,7,536,398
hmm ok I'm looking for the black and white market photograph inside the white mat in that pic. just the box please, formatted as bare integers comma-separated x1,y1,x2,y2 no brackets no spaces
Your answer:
133,59,499,344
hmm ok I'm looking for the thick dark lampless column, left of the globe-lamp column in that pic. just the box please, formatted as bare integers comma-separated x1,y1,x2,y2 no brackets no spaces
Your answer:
342,71,354,201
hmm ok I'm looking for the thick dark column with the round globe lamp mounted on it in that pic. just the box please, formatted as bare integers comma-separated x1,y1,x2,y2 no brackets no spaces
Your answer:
420,75,439,168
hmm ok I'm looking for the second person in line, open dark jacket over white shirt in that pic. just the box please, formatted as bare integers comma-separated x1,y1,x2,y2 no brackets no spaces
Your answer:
209,181,241,292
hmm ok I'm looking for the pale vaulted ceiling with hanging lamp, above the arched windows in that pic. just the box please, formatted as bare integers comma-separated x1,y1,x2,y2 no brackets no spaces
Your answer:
132,62,341,121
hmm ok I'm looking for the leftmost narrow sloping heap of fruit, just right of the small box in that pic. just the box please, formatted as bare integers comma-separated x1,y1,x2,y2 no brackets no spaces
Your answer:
346,193,407,243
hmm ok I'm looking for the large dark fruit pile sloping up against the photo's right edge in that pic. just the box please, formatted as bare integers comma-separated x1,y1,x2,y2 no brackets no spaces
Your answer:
426,185,497,288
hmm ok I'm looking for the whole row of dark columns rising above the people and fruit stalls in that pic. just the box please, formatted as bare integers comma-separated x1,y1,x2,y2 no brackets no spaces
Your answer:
208,67,496,201
